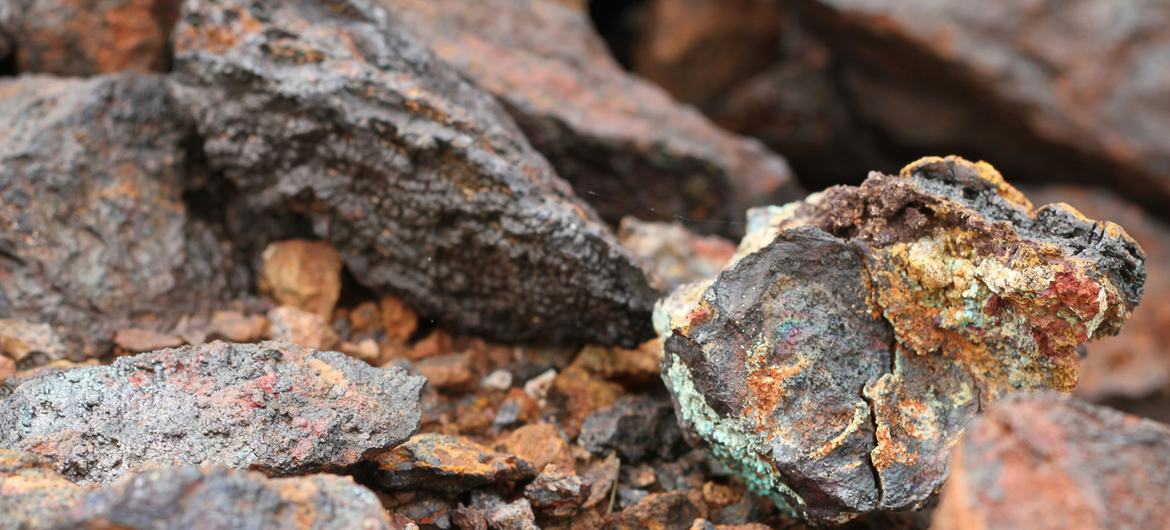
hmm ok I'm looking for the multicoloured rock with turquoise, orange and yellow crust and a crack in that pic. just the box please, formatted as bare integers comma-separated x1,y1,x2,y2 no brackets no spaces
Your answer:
655,157,1145,522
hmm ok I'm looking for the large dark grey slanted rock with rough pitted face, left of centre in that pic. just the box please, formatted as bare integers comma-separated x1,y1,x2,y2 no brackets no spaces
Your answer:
174,0,656,346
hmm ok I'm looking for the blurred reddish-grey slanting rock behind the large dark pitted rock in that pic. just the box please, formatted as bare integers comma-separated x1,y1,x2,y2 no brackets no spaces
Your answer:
380,0,798,233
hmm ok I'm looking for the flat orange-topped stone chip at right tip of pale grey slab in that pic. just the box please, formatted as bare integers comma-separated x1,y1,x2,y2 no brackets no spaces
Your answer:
370,433,536,494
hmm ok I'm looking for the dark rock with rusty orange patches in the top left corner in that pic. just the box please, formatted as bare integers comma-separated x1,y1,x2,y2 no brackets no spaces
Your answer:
0,0,180,76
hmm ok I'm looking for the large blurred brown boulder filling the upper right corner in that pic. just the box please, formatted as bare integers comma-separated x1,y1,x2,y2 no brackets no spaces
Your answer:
794,0,1170,216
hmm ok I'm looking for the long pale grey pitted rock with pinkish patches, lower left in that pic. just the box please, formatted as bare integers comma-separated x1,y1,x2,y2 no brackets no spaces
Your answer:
0,342,425,483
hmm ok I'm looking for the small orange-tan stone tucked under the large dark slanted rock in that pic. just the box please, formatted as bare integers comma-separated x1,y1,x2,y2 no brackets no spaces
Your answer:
259,240,342,319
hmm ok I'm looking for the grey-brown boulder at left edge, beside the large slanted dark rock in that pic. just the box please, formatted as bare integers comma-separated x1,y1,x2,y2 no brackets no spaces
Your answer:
0,75,240,357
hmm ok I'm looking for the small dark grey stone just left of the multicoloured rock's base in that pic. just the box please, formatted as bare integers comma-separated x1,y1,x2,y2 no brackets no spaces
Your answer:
577,395,682,462
